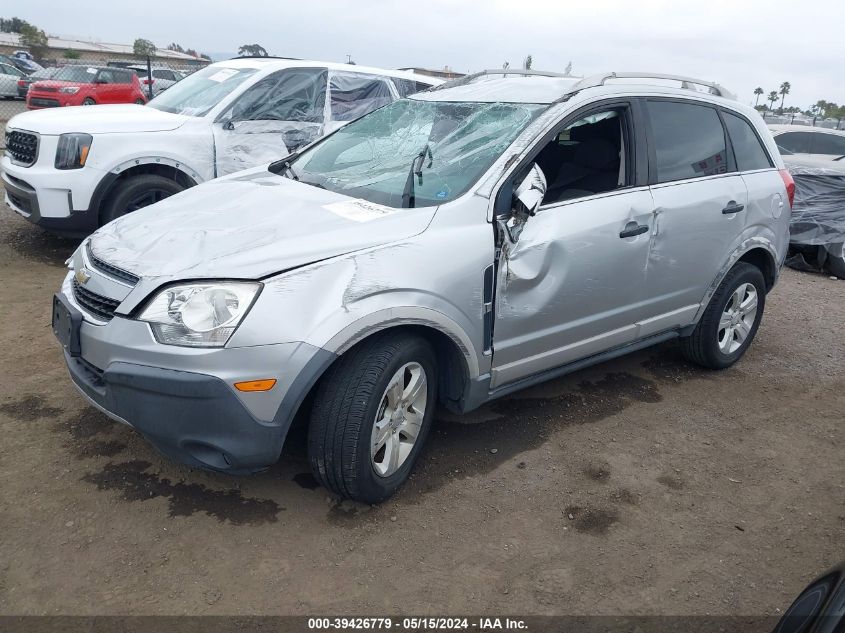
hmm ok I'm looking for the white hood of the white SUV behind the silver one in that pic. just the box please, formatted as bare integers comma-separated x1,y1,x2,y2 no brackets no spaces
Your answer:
7,104,191,134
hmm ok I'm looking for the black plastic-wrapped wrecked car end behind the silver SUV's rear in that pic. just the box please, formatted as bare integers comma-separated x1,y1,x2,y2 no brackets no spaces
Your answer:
783,155,845,279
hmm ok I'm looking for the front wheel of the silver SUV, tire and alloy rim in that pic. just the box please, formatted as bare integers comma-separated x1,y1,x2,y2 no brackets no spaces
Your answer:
308,333,437,503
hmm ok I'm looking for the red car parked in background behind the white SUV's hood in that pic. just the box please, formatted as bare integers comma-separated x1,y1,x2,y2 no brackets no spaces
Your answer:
26,66,147,110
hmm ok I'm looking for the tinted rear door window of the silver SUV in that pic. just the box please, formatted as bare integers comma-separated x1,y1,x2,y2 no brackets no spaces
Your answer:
648,101,728,182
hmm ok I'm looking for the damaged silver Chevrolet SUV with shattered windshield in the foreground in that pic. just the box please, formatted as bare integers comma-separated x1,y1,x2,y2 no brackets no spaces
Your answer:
53,71,794,502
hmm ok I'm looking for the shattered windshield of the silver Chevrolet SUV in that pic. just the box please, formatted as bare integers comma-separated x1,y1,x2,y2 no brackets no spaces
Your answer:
290,99,548,207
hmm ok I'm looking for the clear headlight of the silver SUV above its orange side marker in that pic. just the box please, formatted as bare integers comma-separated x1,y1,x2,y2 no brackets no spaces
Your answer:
138,281,261,347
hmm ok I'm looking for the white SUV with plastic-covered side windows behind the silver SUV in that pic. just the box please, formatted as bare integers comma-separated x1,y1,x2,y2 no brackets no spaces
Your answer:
0,58,441,236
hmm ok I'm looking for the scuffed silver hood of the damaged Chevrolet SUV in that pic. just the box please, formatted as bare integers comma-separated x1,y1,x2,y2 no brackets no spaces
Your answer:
90,167,436,280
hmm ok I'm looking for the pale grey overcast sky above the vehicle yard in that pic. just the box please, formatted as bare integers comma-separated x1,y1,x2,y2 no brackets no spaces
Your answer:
8,0,845,108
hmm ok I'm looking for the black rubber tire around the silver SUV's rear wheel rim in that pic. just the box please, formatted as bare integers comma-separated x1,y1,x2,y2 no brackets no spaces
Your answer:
680,262,766,369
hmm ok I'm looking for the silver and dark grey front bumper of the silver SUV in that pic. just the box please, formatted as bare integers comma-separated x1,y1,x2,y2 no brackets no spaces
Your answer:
56,280,336,474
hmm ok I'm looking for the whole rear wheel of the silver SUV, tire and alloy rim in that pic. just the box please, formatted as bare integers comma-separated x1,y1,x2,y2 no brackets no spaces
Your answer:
681,262,766,369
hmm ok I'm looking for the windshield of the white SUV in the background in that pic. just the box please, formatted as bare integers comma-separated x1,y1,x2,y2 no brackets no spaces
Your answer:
147,66,257,116
